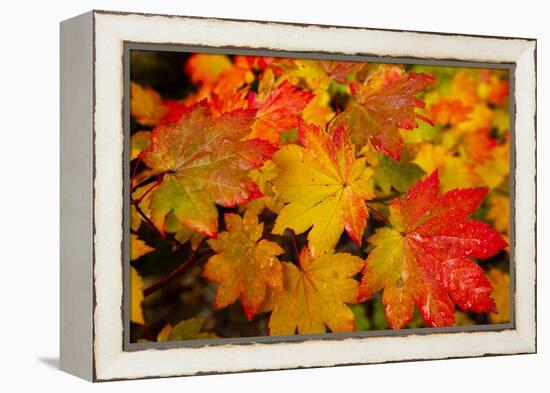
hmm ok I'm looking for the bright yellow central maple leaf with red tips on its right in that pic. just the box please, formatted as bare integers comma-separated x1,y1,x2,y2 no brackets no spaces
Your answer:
272,122,374,255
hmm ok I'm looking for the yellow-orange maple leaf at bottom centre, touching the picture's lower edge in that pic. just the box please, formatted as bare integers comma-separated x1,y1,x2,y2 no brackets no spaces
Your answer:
264,247,365,336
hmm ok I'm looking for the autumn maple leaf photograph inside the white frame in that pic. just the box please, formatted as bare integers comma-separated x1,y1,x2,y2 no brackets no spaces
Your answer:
127,50,511,343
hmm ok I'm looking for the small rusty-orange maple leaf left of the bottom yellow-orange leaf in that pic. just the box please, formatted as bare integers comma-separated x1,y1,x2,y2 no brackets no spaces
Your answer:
203,211,284,320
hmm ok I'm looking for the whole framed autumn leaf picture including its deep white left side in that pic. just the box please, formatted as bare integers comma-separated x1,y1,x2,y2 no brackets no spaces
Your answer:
61,11,536,381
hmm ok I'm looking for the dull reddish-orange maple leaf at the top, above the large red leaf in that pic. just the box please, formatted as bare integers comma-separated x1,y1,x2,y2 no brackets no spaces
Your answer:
331,67,435,161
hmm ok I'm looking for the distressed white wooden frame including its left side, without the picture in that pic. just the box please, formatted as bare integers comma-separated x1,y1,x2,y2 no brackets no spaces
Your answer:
61,11,536,381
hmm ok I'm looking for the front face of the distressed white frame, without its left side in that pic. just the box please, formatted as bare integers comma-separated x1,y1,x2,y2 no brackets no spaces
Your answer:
86,12,536,380
